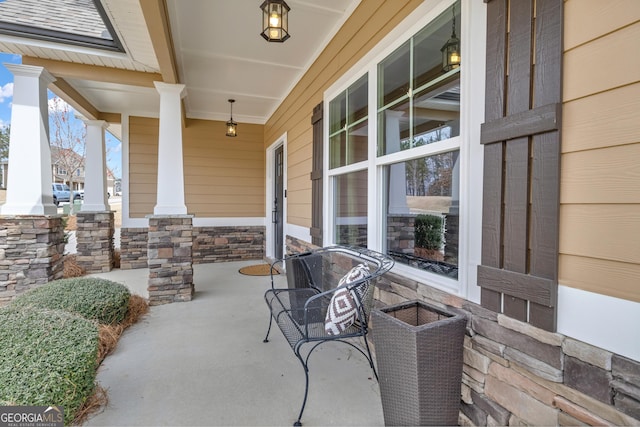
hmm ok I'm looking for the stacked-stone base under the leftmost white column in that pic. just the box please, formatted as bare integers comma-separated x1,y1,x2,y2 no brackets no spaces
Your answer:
0,219,65,306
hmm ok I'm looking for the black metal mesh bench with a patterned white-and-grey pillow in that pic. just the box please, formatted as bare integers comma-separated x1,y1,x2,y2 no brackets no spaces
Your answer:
264,246,394,426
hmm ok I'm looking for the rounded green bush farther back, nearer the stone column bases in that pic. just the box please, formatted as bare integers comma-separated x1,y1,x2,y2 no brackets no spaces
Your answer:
11,277,131,324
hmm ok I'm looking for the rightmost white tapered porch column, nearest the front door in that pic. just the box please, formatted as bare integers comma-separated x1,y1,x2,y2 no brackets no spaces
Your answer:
153,82,187,215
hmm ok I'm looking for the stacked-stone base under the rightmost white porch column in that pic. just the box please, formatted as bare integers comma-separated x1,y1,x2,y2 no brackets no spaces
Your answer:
147,215,195,305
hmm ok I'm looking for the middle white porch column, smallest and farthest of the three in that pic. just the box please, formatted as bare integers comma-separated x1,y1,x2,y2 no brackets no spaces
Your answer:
80,120,109,212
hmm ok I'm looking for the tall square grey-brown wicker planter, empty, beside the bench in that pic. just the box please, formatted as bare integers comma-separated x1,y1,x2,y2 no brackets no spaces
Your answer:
371,301,467,425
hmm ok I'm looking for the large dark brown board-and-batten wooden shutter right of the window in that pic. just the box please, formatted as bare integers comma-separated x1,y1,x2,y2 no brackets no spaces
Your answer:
478,0,563,331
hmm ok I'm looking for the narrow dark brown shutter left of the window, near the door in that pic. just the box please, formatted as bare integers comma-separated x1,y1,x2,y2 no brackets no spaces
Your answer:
311,102,323,246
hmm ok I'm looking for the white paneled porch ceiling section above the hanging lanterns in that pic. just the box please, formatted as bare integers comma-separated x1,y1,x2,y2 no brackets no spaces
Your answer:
167,0,359,123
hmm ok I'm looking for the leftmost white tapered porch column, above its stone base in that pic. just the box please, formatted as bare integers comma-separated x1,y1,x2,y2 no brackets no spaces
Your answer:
0,64,58,215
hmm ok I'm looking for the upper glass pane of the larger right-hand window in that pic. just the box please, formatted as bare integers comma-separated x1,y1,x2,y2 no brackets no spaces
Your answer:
378,7,460,156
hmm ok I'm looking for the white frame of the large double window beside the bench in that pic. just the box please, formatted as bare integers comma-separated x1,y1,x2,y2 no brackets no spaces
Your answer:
323,0,486,302
